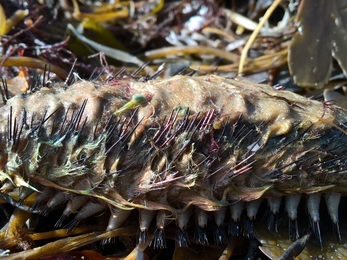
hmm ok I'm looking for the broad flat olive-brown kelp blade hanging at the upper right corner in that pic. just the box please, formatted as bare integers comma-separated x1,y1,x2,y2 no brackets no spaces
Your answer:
288,0,347,88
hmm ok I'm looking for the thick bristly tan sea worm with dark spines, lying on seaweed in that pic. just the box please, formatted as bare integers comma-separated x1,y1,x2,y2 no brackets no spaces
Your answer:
0,75,347,256
